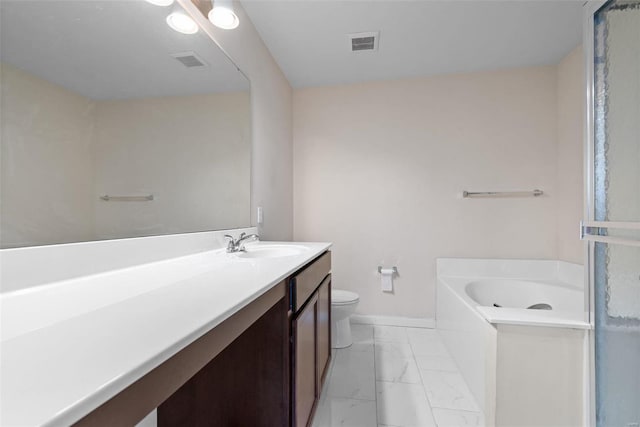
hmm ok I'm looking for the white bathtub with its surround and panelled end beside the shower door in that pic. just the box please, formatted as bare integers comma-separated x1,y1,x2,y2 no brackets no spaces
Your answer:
436,259,589,426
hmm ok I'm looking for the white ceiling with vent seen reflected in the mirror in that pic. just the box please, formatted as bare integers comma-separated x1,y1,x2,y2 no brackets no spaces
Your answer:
0,0,249,100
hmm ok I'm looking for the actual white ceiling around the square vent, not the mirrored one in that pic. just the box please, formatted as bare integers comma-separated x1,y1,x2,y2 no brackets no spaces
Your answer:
242,0,583,88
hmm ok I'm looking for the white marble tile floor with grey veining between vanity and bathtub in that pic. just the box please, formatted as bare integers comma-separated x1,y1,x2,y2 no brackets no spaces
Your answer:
312,324,483,427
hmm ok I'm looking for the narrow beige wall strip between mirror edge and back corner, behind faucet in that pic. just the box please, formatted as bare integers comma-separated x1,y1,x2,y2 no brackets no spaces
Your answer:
180,0,293,240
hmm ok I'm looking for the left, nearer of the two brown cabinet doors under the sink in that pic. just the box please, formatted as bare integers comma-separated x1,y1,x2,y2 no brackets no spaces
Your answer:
293,293,318,427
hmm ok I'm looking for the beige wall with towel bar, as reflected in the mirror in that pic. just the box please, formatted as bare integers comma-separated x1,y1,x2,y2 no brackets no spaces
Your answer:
92,92,251,239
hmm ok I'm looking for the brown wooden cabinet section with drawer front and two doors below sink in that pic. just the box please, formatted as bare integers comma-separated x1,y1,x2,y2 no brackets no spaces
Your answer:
290,253,331,427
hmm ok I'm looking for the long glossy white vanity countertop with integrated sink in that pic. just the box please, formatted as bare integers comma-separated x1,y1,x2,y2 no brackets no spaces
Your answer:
0,242,331,426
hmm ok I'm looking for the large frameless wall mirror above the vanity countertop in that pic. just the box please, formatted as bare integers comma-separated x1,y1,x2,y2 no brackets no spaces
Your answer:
0,0,251,248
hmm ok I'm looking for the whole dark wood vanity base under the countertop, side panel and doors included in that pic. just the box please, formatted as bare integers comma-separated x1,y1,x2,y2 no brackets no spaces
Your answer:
151,252,331,427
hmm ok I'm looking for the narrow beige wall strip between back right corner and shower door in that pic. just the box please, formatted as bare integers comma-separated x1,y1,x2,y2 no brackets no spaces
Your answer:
557,46,586,264
